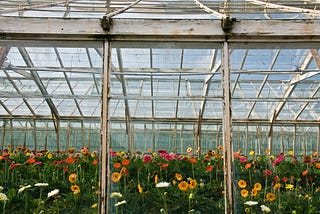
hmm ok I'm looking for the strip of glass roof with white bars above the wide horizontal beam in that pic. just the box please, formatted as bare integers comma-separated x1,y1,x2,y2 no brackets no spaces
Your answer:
0,0,320,19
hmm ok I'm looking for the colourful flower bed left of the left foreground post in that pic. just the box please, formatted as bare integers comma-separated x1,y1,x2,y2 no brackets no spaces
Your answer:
0,145,100,213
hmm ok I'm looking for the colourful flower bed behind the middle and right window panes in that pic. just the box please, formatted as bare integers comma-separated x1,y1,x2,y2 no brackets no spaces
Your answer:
109,147,320,213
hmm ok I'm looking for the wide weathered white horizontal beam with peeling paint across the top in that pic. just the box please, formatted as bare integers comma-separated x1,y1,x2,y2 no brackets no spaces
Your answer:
0,17,320,42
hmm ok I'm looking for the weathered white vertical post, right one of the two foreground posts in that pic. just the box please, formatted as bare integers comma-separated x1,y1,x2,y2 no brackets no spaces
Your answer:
222,41,234,214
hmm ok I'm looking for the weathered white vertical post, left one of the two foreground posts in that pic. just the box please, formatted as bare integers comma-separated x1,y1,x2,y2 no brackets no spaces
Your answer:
99,40,111,214
